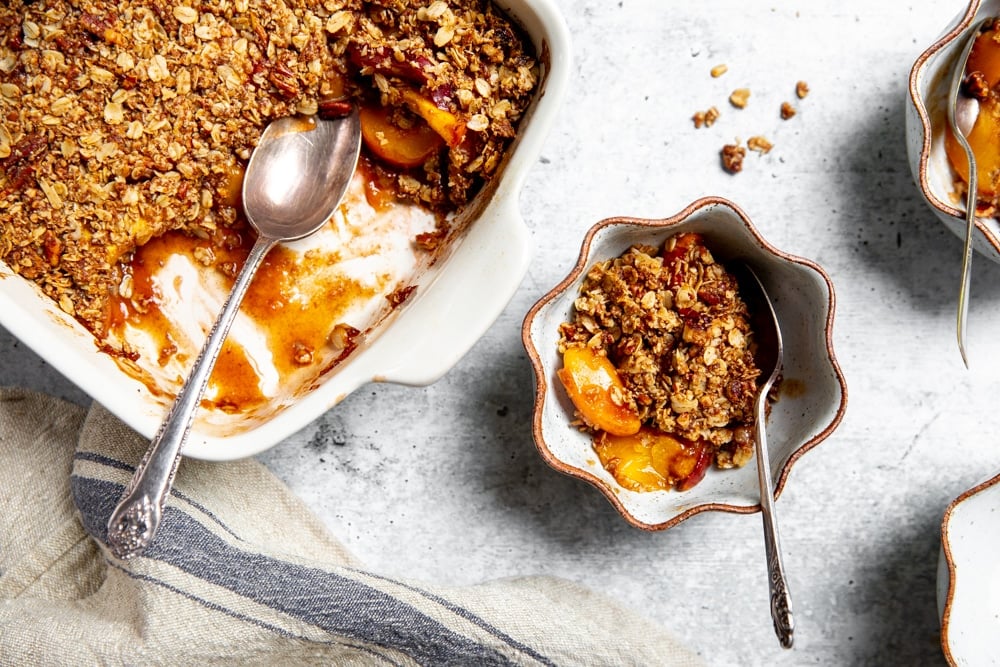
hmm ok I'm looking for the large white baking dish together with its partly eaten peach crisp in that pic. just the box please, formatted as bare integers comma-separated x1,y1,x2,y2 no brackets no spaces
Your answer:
0,0,569,460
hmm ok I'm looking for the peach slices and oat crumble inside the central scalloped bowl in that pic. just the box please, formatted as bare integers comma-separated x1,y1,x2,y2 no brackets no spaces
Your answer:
558,233,759,491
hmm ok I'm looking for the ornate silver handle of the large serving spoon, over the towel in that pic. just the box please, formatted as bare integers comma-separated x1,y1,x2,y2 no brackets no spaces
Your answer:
108,236,277,559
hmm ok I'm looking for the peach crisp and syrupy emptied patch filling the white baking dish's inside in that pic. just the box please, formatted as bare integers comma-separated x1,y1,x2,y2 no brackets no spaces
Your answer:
0,0,539,414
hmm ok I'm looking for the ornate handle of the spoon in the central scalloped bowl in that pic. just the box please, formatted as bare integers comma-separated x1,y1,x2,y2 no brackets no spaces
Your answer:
754,394,795,648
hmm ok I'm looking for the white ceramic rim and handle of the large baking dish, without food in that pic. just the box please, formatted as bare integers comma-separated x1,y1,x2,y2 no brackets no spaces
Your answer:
0,0,570,460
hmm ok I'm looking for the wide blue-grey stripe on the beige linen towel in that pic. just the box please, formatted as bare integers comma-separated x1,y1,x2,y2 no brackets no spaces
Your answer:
71,475,522,665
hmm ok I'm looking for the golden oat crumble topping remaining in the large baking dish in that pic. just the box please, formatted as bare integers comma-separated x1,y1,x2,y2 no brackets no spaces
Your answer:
0,0,538,337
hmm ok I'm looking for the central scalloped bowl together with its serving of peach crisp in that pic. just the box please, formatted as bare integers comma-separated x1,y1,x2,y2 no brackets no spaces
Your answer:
522,198,847,530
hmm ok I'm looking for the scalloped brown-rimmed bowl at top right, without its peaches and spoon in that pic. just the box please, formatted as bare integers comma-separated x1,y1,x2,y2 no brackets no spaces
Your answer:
906,0,1000,262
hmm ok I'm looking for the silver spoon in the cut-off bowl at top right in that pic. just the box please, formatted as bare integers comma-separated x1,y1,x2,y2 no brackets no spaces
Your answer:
948,18,993,368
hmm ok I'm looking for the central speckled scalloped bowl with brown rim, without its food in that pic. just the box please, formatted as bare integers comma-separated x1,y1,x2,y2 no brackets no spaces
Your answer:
522,198,847,530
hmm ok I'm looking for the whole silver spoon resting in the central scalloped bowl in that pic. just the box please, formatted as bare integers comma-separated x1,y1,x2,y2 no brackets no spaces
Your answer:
736,264,795,648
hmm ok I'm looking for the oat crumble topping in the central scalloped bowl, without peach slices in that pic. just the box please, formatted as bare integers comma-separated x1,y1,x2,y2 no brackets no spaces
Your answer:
559,234,759,468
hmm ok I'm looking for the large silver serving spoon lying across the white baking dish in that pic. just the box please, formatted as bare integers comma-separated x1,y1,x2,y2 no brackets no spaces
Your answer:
108,110,361,559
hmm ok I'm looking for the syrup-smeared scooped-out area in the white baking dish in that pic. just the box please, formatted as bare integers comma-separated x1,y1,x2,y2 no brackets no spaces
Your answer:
102,171,435,428
